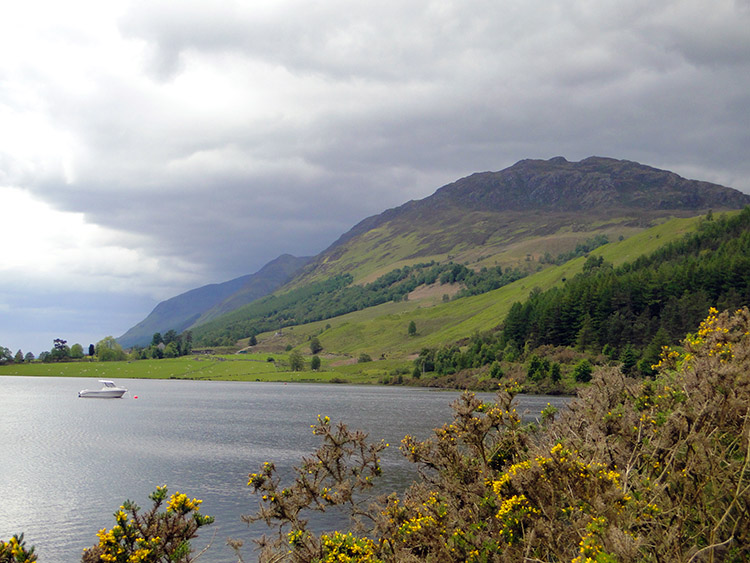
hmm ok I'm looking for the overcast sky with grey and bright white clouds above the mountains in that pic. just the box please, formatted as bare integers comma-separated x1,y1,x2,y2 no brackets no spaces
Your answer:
0,0,750,354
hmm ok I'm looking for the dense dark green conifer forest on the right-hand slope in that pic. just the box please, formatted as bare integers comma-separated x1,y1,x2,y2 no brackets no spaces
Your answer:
500,208,750,373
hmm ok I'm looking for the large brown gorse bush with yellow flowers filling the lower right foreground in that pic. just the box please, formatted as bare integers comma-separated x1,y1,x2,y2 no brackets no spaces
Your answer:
242,308,750,563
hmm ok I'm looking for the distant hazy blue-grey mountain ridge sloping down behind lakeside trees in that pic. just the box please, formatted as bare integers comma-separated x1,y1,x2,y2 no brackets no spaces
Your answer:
117,254,310,348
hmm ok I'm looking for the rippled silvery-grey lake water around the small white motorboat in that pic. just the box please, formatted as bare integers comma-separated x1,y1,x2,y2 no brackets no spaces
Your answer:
0,377,564,563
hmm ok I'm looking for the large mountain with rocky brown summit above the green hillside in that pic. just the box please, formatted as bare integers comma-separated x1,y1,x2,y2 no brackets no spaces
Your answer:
295,157,750,284
